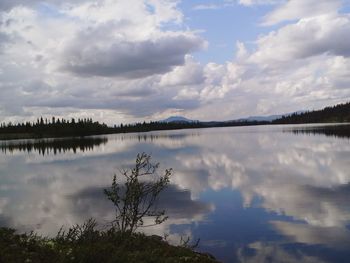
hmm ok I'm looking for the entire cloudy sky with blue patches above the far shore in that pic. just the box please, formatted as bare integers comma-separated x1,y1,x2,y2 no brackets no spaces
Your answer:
0,0,350,124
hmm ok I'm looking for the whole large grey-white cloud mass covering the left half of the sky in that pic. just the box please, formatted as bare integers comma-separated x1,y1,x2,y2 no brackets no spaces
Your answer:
0,0,206,122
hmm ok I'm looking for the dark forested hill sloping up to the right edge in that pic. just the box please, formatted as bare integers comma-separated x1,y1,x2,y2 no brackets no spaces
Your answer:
272,102,350,124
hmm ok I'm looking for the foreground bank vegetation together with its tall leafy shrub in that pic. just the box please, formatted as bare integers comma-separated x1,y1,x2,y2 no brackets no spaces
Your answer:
0,153,217,263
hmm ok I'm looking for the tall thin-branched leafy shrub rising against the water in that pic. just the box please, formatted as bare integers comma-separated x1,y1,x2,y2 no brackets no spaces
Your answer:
104,153,172,234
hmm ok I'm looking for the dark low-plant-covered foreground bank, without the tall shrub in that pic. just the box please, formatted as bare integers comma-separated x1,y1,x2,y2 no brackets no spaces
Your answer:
0,224,218,263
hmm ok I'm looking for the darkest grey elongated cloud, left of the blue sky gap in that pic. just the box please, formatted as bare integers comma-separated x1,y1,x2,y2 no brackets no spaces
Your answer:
61,32,203,78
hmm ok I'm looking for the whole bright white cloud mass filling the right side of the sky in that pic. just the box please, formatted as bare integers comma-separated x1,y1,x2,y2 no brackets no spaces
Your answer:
168,1,350,120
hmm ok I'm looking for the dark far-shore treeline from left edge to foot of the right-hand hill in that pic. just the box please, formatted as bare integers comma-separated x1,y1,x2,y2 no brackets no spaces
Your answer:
0,117,268,140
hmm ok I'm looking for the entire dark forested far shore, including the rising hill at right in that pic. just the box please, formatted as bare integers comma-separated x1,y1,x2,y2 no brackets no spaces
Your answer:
0,102,350,140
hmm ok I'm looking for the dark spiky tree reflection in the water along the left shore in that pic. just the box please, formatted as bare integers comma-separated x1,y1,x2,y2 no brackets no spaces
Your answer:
0,137,108,155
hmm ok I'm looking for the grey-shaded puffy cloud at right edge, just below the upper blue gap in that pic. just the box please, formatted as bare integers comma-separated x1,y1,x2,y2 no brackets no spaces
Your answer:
251,15,350,64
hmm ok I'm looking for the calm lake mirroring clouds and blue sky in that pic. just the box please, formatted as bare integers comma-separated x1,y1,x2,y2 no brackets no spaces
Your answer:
0,125,350,262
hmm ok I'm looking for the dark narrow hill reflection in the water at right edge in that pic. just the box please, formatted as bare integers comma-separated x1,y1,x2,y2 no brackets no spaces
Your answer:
289,125,350,138
